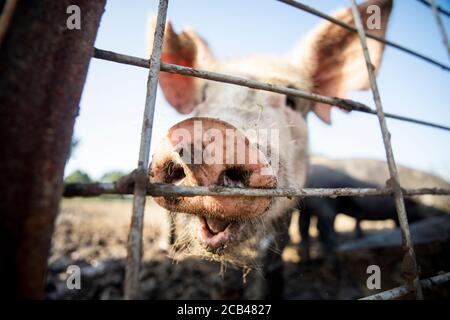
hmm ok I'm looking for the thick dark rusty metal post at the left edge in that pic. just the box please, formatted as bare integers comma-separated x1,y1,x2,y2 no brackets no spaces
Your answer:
0,0,105,299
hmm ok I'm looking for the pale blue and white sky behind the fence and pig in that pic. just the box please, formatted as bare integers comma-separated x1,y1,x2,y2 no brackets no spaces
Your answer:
66,0,450,180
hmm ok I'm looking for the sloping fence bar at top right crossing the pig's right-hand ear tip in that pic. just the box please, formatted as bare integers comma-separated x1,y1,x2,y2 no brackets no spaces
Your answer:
278,0,450,71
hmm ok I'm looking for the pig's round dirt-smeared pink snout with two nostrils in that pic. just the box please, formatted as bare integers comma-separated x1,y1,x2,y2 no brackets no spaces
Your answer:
150,117,277,222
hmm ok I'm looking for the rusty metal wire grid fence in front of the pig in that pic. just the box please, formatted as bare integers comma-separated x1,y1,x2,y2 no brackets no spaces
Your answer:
64,0,450,299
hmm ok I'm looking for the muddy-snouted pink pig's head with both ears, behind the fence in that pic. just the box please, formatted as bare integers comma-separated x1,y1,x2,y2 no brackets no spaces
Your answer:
149,0,392,265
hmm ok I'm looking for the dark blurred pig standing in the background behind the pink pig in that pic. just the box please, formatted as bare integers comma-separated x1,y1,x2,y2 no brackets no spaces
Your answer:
295,162,446,261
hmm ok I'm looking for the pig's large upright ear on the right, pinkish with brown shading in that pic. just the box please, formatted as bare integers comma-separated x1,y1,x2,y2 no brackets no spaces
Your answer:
296,0,392,123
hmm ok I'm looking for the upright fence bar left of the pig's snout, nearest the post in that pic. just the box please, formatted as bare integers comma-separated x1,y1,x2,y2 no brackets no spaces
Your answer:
124,0,169,299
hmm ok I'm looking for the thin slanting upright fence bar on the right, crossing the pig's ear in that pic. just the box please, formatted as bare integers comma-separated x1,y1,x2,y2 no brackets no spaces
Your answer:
351,0,423,299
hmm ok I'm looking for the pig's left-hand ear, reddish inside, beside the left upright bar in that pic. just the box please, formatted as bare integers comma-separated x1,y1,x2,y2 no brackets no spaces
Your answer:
149,17,213,113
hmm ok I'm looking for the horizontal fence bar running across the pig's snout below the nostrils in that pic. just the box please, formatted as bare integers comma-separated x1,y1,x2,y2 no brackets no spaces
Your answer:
63,183,450,197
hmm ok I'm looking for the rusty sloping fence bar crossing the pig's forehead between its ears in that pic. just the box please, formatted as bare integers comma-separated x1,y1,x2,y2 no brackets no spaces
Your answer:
94,49,450,131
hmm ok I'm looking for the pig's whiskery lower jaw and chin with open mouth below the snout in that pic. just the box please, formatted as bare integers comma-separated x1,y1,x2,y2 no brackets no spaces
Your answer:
172,198,287,268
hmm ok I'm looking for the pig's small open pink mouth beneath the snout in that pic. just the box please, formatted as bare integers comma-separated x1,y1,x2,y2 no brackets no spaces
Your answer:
198,216,245,253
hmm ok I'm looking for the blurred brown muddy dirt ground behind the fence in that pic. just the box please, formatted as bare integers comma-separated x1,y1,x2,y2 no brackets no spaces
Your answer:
46,199,450,299
